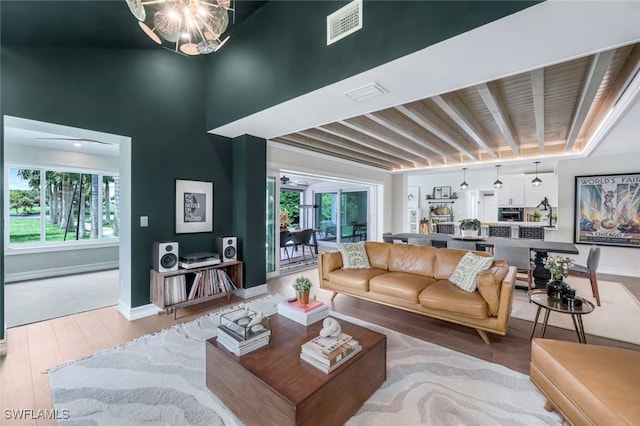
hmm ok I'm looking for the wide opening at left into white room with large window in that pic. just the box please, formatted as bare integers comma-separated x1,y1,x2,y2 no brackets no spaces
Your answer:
2,116,131,327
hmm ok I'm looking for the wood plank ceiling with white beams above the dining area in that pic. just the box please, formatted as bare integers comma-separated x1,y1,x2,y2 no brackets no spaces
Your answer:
272,43,640,171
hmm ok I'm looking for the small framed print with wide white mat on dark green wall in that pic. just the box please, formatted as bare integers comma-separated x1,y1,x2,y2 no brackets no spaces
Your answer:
176,179,213,234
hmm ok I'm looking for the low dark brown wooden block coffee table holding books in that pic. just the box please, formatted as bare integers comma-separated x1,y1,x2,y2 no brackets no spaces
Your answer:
206,315,387,425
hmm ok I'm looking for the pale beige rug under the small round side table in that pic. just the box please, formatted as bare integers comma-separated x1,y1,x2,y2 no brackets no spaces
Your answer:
511,277,640,345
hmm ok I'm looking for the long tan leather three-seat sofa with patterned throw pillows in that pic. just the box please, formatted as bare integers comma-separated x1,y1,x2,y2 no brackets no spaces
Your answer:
318,241,516,344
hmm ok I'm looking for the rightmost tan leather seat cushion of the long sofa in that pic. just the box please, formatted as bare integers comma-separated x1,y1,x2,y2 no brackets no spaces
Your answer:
418,280,489,319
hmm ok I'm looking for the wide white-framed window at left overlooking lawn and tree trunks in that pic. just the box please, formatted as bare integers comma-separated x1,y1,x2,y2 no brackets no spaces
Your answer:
8,167,119,247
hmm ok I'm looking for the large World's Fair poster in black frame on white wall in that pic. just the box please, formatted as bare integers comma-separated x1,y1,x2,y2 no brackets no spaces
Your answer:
574,173,640,248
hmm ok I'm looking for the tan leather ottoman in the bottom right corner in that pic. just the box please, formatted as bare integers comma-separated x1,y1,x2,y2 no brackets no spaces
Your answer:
529,338,640,426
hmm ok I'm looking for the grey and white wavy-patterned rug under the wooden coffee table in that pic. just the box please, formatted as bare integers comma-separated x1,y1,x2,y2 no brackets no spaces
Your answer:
49,296,561,426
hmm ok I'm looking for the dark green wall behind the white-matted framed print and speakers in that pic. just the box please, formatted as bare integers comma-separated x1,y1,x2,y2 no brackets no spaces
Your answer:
0,48,234,307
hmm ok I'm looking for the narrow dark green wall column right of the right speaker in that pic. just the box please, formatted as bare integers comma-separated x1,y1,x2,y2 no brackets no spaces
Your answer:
233,135,267,287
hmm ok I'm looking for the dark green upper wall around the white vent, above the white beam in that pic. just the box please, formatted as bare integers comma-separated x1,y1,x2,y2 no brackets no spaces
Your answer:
207,0,539,129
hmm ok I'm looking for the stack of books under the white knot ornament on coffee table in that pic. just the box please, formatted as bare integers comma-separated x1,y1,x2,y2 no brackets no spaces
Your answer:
300,333,362,374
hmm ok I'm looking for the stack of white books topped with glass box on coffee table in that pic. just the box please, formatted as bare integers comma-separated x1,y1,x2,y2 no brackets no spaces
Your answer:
217,315,271,356
